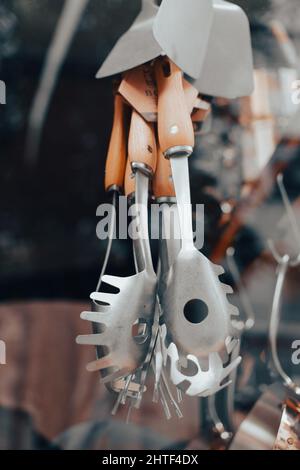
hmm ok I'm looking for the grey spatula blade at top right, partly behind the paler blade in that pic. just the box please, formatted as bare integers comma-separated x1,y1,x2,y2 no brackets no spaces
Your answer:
188,0,254,99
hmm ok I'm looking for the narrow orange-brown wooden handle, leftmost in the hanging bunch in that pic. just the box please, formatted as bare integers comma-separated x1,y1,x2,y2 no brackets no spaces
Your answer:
105,94,126,191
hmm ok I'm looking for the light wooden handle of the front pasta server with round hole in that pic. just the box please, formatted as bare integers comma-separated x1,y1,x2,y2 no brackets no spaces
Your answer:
155,58,195,156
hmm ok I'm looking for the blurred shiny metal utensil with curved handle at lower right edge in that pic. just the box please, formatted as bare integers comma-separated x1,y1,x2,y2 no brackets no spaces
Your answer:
231,178,300,450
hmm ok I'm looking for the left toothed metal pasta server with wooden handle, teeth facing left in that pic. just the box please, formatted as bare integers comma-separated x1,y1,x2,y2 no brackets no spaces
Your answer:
77,111,156,383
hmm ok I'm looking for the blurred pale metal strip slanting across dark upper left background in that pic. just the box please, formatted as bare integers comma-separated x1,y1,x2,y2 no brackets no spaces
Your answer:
25,0,89,165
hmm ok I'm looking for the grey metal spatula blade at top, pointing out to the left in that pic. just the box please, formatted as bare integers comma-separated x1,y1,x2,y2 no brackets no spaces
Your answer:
96,0,162,78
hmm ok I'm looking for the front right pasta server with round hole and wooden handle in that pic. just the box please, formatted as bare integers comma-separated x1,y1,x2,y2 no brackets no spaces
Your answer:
156,58,240,396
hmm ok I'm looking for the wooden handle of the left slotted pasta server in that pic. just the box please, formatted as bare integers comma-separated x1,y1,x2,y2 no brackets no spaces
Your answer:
128,110,157,174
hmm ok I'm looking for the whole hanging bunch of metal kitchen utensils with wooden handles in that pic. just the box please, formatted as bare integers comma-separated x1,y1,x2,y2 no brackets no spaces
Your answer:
77,0,253,417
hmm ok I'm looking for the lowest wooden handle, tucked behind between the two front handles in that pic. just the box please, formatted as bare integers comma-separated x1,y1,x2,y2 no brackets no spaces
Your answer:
152,149,175,199
